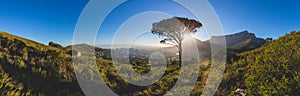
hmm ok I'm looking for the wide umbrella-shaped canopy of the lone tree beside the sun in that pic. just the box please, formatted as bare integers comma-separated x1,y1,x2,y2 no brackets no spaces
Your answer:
151,17,202,49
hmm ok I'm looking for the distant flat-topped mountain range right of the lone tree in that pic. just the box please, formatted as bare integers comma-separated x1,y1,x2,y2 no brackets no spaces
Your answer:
194,31,266,56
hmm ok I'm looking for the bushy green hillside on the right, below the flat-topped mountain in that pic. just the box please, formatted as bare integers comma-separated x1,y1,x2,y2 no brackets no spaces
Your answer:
218,32,300,96
